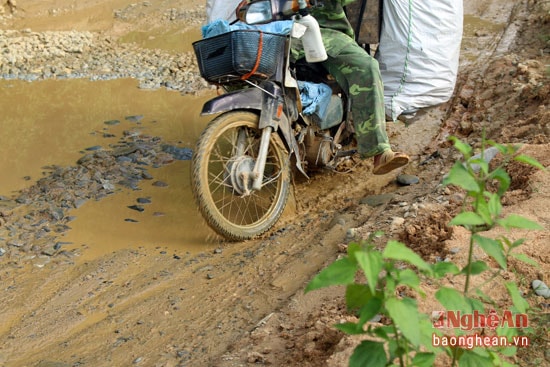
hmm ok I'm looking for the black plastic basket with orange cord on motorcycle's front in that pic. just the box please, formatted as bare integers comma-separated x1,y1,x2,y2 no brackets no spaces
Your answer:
193,30,286,83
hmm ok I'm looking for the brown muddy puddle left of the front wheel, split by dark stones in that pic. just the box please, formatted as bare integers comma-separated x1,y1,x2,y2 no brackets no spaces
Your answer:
0,80,222,259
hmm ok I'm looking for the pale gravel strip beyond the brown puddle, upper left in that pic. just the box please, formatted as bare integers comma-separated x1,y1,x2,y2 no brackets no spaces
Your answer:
0,2,213,94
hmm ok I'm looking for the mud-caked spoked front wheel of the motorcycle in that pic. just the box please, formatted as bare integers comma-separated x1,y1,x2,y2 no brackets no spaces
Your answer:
191,111,290,241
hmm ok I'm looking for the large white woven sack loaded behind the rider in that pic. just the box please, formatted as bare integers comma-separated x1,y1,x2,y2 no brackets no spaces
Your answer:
376,0,463,121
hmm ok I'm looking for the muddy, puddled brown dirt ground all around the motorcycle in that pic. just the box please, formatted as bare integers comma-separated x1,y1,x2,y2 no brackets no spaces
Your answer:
0,0,550,367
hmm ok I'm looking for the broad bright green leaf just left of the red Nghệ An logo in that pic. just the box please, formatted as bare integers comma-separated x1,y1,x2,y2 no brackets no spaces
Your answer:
386,298,420,347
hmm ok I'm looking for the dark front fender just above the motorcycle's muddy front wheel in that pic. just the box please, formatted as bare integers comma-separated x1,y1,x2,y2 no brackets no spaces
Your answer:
201,88,263,115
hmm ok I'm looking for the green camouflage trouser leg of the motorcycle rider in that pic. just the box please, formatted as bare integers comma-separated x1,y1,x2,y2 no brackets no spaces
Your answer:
323,32,390,157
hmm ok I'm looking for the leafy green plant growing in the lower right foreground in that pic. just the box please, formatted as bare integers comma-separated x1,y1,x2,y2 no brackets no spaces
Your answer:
306,137,544,367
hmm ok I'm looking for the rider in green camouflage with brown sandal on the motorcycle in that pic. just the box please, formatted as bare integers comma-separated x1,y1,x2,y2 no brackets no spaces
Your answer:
207,0,409,175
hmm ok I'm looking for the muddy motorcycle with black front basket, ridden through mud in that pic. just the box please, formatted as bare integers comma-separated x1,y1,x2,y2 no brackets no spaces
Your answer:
191,0,355,241
